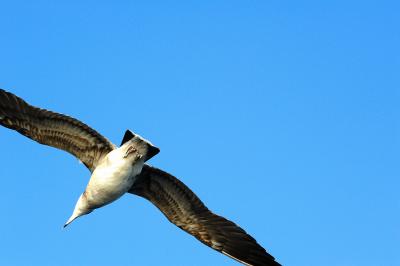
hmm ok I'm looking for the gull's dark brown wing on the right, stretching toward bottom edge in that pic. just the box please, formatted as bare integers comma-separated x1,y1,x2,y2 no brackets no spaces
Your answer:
129,165,280,266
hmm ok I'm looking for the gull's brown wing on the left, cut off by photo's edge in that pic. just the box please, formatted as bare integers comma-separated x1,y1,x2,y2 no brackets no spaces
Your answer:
0,89,115,172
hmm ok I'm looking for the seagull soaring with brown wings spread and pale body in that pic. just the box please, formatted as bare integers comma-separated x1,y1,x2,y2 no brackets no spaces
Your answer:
0,89,280,266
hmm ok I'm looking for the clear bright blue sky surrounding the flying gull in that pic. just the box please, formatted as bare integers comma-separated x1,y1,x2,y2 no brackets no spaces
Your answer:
0,0,400,266
